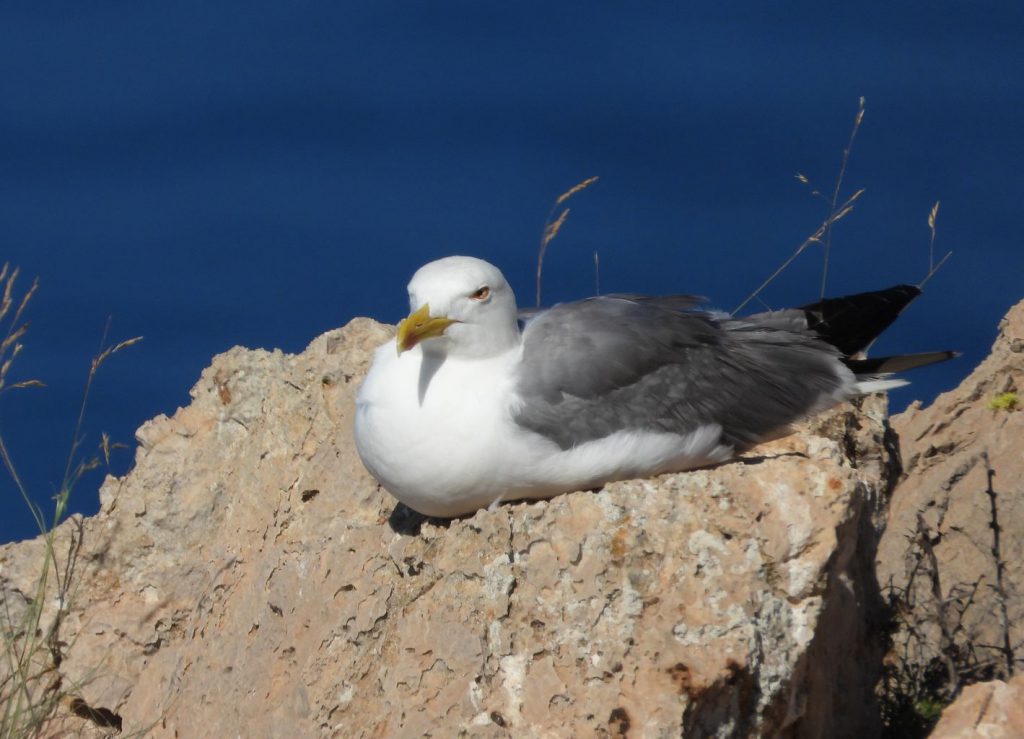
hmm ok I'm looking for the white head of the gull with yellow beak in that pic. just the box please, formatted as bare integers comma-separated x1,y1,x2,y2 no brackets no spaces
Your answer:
395,257,519,357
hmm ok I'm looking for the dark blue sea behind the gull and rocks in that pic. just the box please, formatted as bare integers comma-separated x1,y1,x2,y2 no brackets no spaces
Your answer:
0,1,1024,540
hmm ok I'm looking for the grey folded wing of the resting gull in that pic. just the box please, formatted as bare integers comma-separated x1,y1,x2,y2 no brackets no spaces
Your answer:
516,296,849,448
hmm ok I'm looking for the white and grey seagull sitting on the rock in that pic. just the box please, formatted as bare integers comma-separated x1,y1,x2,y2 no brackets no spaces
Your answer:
354,257,955,518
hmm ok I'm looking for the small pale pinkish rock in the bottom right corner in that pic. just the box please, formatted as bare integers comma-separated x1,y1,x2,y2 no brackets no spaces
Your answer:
931,675,1024,739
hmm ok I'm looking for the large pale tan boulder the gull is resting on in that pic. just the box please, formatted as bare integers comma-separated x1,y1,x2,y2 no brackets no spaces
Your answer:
0,319,892,737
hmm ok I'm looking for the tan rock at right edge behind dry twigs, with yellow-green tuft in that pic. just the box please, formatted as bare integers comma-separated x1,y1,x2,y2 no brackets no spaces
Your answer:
878,302,1024,691
